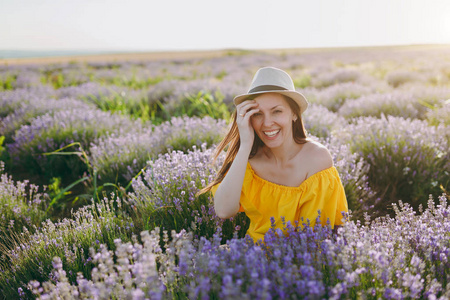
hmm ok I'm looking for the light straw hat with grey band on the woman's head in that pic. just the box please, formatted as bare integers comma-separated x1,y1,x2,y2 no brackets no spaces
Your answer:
233,67,308,114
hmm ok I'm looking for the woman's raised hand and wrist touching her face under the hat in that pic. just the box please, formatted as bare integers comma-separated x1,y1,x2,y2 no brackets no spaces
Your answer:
236,100,259,149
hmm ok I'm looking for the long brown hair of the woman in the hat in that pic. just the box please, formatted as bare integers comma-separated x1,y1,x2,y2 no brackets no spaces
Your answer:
198,95,306,195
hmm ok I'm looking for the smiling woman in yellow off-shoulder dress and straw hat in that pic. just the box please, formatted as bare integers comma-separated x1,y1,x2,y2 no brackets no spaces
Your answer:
201,67,348,241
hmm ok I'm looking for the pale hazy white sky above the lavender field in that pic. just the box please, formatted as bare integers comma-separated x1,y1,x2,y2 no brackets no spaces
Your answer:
0,0,450,51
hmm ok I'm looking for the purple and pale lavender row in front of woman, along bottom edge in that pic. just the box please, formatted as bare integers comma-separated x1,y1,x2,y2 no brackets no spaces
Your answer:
28,196,450,299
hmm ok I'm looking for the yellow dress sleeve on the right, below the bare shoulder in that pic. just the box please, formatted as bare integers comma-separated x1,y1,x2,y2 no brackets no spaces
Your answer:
299,167,348,228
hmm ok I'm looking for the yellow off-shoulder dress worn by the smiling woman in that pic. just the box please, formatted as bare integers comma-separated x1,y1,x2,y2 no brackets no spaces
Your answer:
212,163,348,241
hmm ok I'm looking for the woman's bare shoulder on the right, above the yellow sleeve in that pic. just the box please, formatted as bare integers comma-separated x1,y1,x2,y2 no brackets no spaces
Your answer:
302,140,333,176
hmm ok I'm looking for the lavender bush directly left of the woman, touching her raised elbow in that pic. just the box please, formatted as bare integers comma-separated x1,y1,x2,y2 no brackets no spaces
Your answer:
129,144,249,238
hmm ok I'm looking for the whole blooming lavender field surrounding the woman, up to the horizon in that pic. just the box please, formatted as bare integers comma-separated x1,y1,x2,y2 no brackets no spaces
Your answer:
0,47,450,299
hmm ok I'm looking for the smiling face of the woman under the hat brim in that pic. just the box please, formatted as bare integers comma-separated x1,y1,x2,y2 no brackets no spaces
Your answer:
251,93,297,148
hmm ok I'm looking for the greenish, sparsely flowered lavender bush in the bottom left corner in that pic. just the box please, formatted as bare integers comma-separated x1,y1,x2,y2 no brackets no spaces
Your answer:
0,197,133,299
